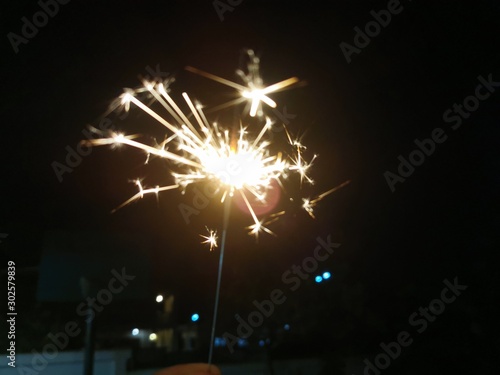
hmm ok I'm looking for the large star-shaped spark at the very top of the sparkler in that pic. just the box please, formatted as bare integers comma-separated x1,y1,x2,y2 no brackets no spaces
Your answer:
186,50,299,117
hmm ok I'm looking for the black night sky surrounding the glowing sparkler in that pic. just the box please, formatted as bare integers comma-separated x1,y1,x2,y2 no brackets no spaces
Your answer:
0,0,500,374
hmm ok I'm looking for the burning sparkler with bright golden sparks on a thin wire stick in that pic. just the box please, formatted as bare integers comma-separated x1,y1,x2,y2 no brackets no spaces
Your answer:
85,50,348,370
